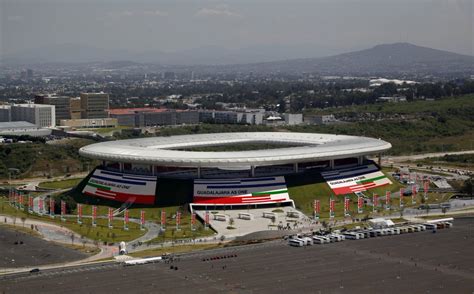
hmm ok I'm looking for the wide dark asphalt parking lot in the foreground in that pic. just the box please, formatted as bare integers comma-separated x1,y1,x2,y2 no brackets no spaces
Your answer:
0,218,474,293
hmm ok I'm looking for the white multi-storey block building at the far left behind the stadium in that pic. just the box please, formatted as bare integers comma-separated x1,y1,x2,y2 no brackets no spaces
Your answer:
11,104,56,128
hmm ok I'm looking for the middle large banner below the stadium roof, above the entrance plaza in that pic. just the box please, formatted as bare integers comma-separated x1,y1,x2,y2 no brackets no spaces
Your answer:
193,177,290,204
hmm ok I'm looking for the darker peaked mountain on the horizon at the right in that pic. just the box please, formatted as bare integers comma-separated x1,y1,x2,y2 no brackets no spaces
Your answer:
227,43,474,74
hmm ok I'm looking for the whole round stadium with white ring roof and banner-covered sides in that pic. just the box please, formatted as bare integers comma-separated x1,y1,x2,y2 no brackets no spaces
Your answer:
79,132,391,209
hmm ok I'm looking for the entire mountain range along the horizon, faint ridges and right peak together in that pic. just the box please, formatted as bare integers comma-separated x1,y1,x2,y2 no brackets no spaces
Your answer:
2,43,474,75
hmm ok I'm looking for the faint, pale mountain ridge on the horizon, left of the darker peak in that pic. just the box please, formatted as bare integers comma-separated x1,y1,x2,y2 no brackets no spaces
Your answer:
0,44,340,65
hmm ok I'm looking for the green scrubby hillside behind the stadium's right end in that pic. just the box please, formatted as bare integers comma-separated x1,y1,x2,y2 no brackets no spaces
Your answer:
298,95,474,155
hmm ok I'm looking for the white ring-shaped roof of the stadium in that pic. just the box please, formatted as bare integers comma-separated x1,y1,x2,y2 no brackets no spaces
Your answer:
79,132,392,168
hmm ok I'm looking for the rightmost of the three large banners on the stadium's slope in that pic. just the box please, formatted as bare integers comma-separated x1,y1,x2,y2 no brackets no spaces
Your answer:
321,164,392,195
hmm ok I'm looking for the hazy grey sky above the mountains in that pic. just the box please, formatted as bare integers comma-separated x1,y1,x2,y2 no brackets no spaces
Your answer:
0,0,474,55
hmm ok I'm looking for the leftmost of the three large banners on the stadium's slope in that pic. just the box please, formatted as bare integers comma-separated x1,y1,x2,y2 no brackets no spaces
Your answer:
82,169,156,204
